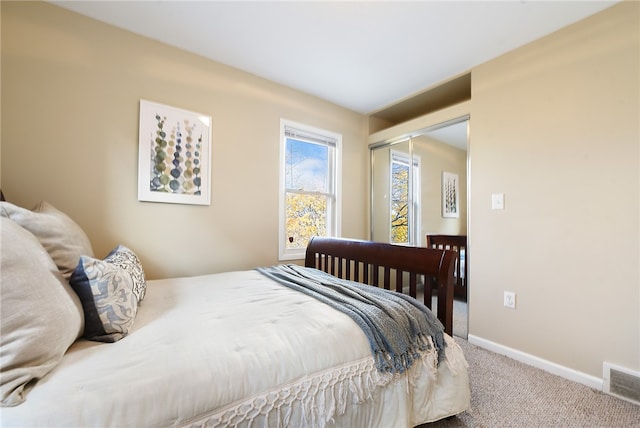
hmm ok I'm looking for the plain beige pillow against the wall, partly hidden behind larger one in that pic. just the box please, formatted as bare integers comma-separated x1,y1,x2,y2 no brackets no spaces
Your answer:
0,202,93,280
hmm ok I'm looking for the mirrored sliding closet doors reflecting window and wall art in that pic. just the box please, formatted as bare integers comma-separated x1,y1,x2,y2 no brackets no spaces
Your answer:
369,116,469,338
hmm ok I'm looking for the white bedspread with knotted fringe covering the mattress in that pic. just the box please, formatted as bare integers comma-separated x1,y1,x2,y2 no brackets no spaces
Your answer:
0,271,469,427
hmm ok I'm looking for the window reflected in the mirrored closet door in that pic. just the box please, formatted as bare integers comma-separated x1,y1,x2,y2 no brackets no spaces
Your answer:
389,150,420,245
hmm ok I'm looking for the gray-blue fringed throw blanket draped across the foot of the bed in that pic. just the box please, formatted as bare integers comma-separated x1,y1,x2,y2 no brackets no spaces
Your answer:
257,265,445,373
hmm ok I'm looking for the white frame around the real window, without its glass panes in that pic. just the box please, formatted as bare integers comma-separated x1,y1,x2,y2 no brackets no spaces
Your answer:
278,119,342,260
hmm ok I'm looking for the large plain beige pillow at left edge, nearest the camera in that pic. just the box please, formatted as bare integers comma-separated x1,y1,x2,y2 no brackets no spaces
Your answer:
0,217,83,406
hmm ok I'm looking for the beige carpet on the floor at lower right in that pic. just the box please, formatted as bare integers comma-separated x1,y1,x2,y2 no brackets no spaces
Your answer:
421,337,640,428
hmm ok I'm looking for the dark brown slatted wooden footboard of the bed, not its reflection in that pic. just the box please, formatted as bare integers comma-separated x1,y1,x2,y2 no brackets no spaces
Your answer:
305,237,457,335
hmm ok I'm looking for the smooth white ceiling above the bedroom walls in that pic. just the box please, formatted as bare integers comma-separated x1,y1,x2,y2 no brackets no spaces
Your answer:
51,0,617,114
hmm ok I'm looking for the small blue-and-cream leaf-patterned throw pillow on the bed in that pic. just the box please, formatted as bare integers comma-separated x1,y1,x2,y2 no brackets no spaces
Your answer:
69,252,138,342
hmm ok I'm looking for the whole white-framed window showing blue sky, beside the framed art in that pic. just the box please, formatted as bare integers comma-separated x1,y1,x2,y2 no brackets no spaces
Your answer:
279,120,342,260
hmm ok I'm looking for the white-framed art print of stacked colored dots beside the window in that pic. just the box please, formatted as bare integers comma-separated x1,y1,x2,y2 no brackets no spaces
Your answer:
138,100,211,205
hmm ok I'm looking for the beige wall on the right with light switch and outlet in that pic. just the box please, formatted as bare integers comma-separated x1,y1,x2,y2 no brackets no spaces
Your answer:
469,2,640,377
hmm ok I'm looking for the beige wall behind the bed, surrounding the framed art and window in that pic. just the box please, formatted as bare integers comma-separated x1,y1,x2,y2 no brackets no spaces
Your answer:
1,2,368,278
